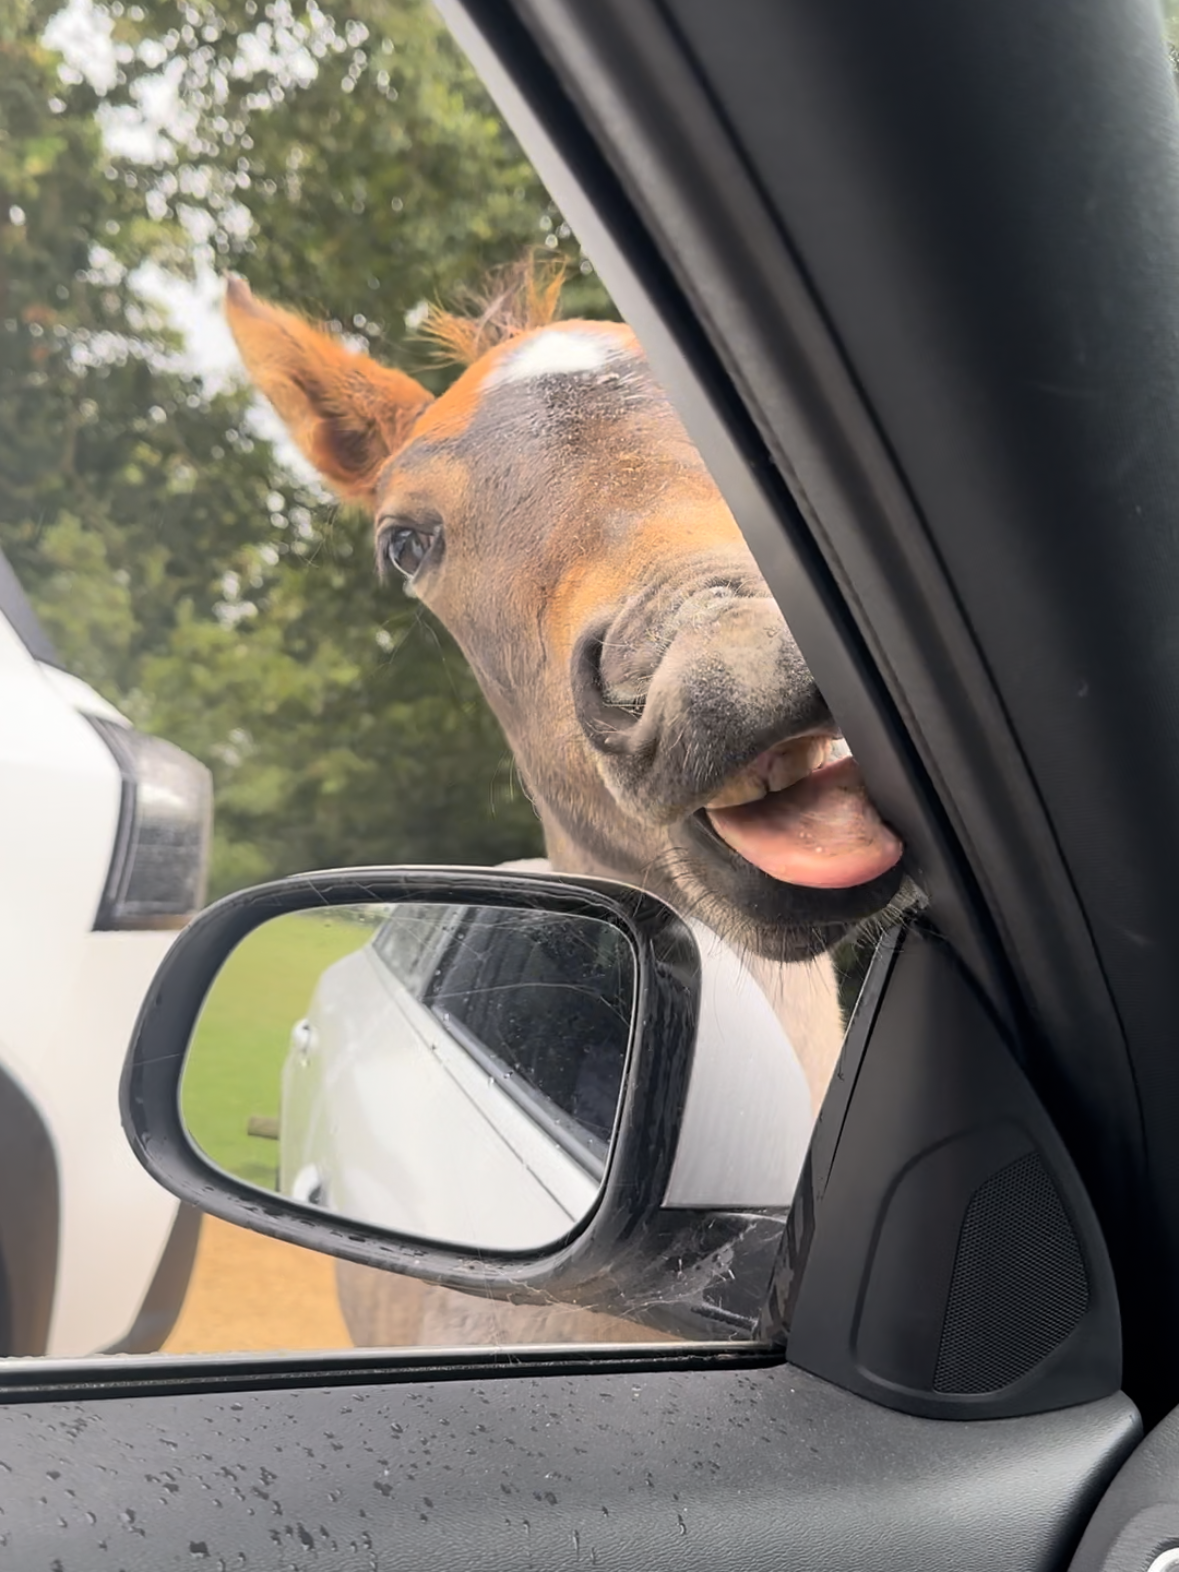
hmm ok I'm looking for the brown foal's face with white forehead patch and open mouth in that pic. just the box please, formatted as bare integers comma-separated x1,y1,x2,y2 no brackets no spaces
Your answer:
228,273,902,960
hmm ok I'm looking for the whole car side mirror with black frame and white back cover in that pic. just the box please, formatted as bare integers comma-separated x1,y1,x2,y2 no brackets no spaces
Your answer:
121,868,810,1338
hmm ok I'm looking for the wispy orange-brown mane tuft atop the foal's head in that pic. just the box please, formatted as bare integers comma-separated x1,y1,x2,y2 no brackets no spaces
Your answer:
418,252,567,366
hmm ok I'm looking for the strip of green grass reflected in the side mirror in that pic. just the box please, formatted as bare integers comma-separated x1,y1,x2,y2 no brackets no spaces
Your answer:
181,912,374,1190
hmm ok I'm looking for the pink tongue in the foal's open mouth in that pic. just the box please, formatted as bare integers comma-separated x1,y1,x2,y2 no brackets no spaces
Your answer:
707,758,904,890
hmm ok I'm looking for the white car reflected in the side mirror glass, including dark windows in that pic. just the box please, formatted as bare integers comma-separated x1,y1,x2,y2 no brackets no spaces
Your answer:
278,904,634,1250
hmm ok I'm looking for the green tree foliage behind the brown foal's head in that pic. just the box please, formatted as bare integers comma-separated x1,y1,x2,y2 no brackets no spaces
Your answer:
0,0,610,893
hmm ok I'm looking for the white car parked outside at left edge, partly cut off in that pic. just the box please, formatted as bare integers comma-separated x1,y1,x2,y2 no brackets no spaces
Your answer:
0,555,212,1357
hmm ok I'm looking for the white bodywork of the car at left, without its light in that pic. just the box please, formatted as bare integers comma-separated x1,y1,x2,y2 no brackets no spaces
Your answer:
0,591,184,1357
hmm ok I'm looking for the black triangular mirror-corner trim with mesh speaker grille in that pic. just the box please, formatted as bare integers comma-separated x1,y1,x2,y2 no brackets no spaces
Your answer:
761,921,1121,1420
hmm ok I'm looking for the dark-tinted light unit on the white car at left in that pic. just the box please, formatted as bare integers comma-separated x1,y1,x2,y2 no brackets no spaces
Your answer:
86,715,212,929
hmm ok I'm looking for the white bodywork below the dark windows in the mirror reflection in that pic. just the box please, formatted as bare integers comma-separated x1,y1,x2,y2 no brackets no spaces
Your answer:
280,945,599,1250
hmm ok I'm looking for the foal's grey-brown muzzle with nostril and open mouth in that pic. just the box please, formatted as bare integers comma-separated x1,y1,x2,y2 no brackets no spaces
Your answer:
571,593,904,916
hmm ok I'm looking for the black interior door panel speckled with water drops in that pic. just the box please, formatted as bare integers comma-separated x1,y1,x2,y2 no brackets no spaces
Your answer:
0,1350,1138,1572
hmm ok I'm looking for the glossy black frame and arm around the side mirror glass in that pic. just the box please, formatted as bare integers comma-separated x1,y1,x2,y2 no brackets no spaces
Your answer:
119,868,783,1338
